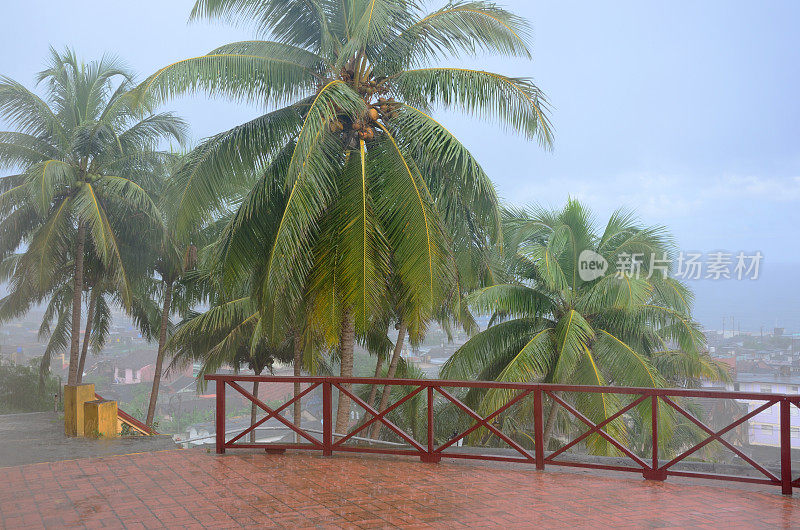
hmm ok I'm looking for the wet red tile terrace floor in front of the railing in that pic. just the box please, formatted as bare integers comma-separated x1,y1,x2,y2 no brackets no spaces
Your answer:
0,449,800,528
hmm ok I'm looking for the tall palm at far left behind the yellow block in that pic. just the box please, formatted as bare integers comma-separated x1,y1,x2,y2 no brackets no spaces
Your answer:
0,49,185,385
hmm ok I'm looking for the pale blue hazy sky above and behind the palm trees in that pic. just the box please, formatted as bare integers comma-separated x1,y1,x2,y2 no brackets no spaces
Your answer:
0,0,800,329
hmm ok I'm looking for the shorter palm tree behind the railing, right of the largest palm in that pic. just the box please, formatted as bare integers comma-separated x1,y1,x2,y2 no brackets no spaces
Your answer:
442,200,725,452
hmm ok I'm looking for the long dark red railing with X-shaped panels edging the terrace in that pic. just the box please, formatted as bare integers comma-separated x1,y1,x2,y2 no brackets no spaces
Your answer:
205,374,800,494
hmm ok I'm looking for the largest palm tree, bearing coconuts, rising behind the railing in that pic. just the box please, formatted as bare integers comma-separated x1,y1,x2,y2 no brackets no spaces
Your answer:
140,0,551,431
